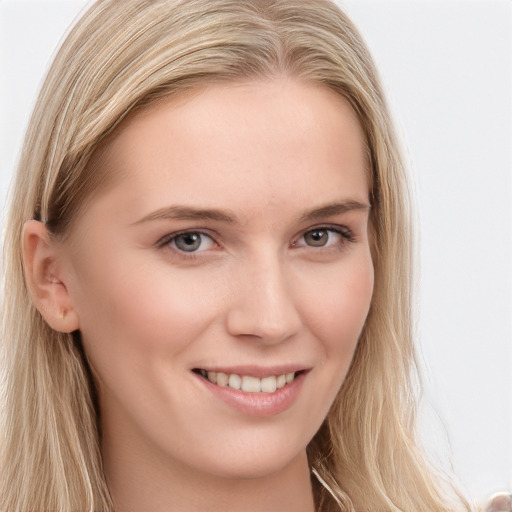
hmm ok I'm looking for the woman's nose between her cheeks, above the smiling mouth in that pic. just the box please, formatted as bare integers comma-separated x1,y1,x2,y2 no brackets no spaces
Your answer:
226,258,302,345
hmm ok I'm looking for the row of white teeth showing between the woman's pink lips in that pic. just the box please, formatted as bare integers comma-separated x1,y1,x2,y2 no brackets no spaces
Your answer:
193,368,303,393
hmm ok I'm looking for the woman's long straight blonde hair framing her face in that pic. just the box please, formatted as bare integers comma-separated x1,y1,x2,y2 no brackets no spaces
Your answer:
0,0,470,512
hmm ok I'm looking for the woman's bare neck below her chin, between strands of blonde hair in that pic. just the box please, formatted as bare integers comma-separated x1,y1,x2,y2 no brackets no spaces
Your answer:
103,432,314,512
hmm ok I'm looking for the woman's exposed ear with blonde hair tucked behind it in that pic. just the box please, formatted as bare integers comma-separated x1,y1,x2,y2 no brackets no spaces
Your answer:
22,220,78,332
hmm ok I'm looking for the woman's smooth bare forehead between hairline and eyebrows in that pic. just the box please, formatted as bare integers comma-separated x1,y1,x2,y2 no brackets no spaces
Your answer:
85,78,368,224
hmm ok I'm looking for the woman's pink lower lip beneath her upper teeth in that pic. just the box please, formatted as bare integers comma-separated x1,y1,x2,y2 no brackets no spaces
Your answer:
196,372,307,417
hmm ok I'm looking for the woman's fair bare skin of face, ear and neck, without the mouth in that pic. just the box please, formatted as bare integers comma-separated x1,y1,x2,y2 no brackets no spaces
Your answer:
24,78,373,512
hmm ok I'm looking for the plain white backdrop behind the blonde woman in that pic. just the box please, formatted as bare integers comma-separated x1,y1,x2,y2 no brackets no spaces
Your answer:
0,0,512,500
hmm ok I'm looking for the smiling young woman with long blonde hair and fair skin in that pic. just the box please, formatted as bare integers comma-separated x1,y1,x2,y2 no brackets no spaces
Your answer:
0,0,472,512
